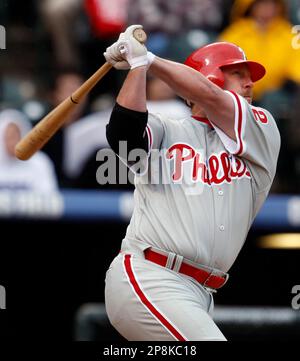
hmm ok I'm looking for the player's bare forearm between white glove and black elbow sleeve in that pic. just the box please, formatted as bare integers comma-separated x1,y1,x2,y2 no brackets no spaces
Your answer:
117,66,147,112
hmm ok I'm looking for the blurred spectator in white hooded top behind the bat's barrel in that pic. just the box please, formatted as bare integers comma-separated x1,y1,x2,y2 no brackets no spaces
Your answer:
0,109,57,192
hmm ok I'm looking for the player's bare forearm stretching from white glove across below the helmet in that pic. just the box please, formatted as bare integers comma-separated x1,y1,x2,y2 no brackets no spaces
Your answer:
149,57,218,105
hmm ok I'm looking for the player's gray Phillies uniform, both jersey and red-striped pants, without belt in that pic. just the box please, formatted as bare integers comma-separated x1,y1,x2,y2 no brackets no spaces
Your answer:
105,92,280,341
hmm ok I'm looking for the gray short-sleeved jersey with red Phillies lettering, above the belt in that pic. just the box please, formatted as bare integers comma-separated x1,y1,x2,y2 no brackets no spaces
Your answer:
122,91,280,272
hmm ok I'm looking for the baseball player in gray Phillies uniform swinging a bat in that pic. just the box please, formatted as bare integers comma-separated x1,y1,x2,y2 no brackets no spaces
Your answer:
104,25,280,341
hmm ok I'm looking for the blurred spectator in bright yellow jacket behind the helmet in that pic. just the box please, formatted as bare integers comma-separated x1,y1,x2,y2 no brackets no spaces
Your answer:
220,0,300,117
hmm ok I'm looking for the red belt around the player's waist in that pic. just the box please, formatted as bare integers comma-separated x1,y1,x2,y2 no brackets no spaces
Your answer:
144,248,228,289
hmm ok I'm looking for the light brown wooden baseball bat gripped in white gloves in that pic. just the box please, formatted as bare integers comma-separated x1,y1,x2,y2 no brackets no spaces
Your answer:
15,29,147,160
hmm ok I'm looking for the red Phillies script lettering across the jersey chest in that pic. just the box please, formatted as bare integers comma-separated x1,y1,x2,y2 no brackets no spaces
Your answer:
166,143,251,185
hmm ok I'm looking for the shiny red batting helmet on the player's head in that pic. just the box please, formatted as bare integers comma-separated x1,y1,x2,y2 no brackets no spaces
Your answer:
184,42,266,88
